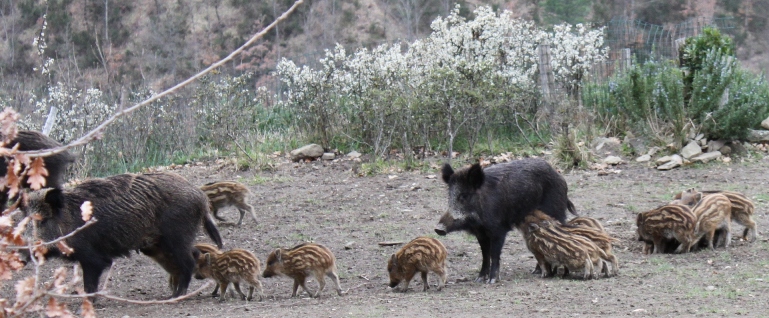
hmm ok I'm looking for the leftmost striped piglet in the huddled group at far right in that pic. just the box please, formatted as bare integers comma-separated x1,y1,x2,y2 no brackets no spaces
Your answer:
636,204,697,254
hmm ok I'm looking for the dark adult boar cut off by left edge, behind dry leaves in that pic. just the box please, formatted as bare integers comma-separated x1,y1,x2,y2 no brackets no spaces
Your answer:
0,130,75,209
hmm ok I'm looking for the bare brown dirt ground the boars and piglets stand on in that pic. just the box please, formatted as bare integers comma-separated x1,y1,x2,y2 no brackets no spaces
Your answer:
3,154,769,318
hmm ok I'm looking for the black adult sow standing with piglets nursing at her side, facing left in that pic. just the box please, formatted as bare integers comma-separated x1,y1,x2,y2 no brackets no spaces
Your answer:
435,159,576,283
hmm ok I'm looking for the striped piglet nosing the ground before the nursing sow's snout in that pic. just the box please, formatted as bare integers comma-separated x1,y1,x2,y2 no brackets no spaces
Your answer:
387,236,448,293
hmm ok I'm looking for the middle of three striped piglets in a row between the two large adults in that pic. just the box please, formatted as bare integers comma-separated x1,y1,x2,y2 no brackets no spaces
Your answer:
262,243,343,298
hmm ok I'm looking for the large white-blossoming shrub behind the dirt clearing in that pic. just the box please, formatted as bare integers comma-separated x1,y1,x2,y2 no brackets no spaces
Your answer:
275,6,606,155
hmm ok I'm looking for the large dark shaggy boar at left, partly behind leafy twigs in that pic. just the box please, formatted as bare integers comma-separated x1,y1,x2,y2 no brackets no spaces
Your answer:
23,173,222,297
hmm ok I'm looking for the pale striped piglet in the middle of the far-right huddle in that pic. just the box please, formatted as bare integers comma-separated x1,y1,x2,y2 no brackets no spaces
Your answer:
689,194,732,250
